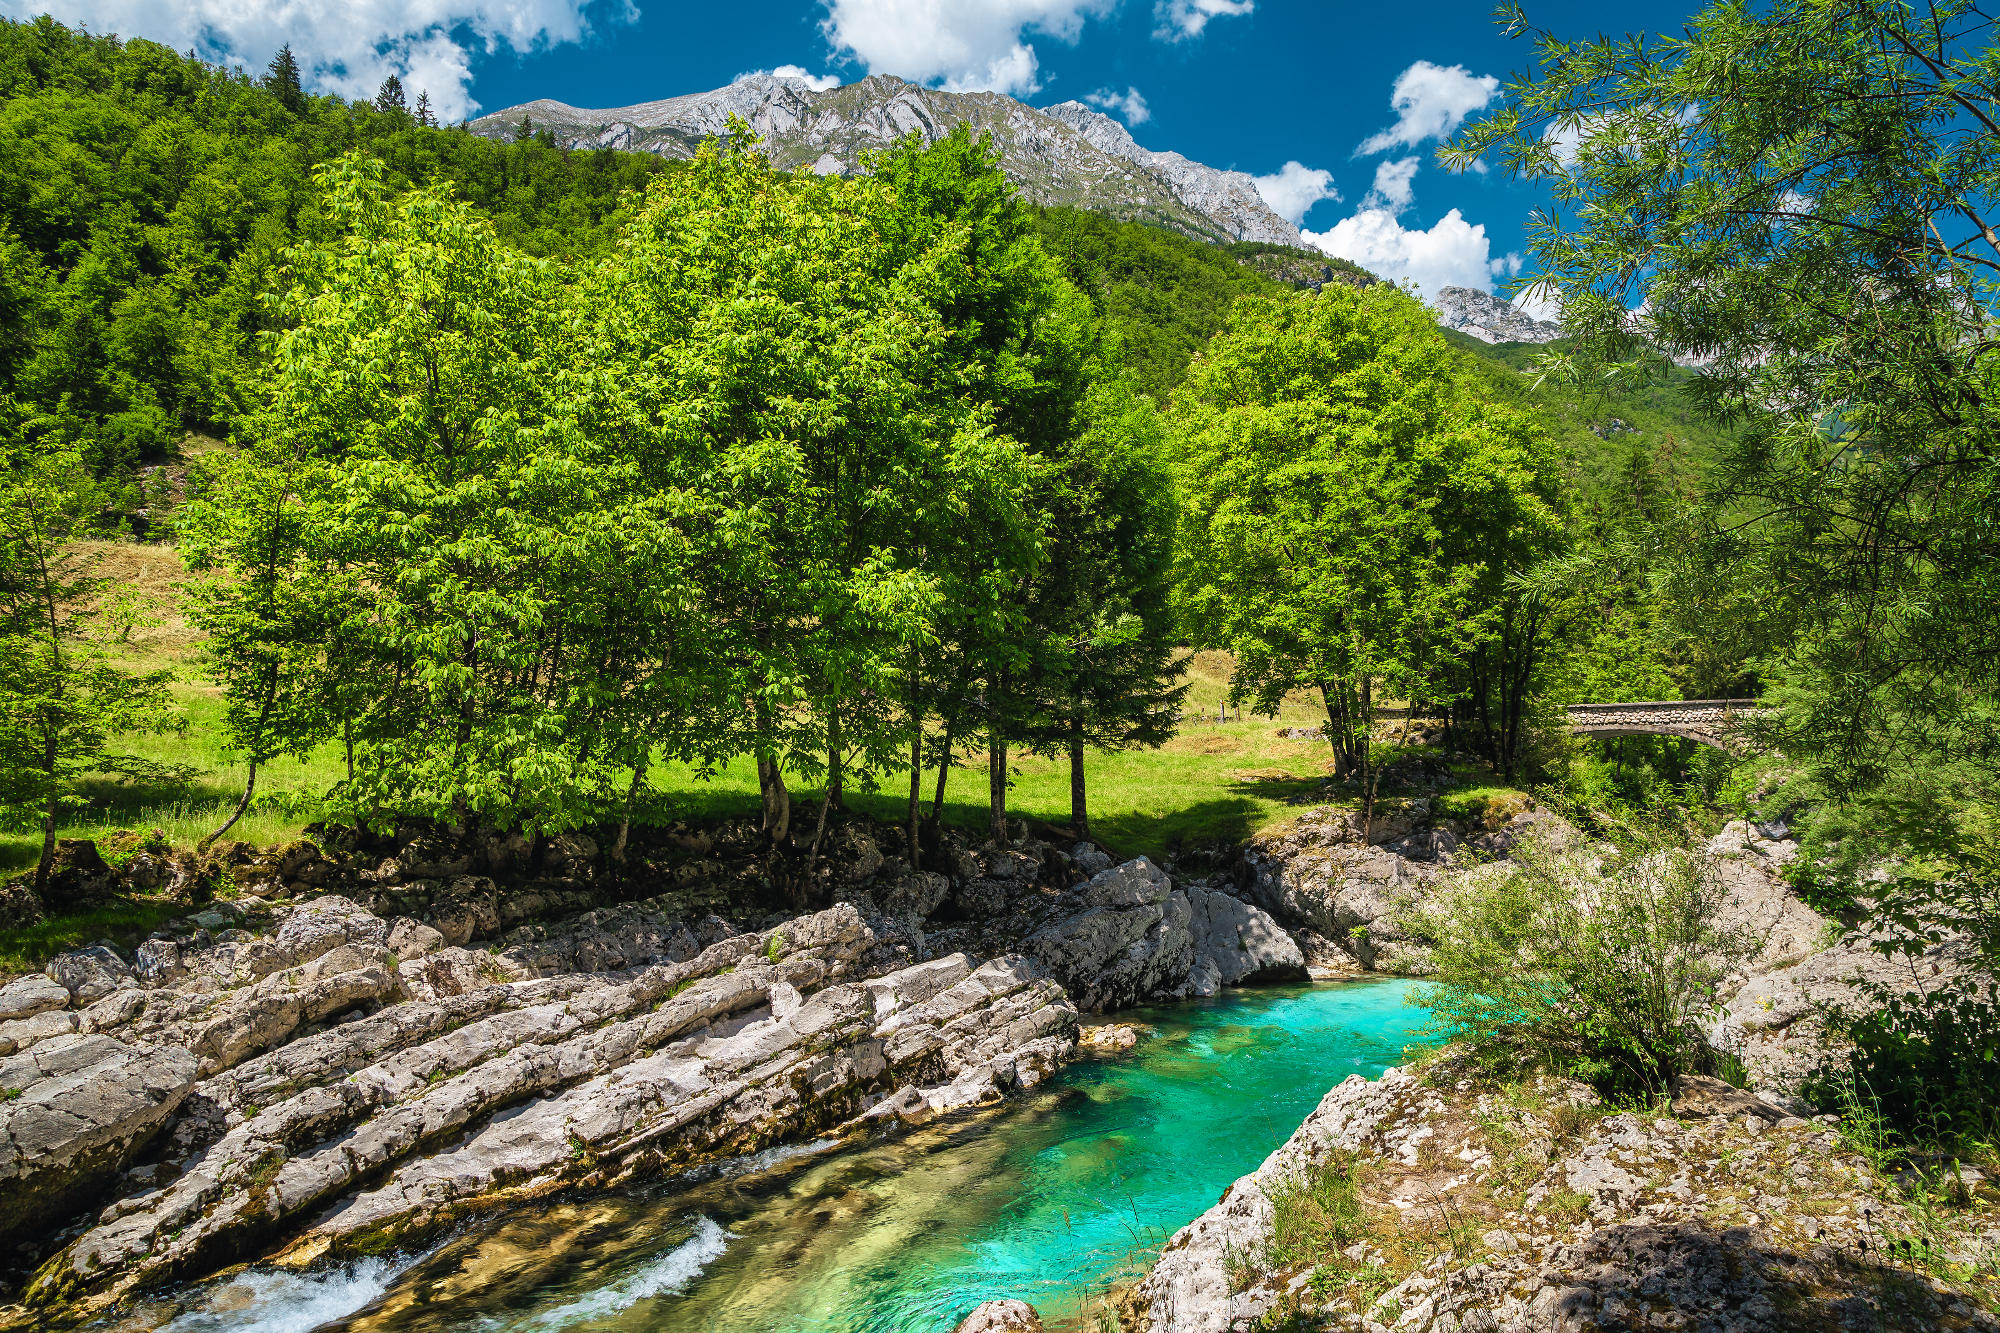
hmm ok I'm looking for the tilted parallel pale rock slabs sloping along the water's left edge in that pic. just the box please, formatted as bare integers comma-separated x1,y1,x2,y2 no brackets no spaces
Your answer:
27,892,1076,1309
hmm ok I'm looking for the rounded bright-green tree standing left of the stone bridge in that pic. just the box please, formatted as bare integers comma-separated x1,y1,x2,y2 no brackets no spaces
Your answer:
1170,286,1562,783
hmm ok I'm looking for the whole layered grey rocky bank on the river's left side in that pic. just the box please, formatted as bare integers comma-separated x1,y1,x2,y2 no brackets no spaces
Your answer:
0,808,1304,1325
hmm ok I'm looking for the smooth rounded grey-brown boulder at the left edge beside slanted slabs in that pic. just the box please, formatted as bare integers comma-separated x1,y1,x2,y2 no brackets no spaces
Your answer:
0,1015,194,1243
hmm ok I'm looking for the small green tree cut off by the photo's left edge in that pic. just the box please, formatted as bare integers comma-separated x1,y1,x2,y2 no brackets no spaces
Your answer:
0,426,184,893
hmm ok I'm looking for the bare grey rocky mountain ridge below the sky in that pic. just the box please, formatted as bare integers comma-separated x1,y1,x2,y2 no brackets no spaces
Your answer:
472,74,1304,246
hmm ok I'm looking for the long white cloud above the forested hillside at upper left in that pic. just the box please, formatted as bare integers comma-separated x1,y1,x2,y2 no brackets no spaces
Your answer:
17,0,638,120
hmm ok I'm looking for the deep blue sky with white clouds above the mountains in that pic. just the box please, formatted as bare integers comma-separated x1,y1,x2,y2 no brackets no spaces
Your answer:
0,0,1692,300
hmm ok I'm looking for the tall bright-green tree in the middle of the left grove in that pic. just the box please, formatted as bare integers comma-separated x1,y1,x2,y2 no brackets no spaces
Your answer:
592,134,1036,897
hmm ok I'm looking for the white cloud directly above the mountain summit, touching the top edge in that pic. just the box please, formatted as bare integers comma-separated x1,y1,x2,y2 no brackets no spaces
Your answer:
820,0,1118,96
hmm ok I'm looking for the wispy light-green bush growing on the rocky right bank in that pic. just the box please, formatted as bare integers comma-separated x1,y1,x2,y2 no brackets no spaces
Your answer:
1402,808,1756,1101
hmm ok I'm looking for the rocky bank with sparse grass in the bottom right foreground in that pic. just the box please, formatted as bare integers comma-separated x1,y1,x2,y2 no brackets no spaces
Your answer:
1122,1055,2000,1333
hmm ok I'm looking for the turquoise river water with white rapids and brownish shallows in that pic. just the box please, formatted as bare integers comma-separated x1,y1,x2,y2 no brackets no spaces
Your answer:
138,981,1420,1333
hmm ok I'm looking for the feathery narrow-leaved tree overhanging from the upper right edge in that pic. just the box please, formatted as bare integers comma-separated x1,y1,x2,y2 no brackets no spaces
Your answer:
1448,0,2000,837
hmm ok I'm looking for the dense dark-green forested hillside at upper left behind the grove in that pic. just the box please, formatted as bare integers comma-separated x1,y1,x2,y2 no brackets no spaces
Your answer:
0,18,664,476
